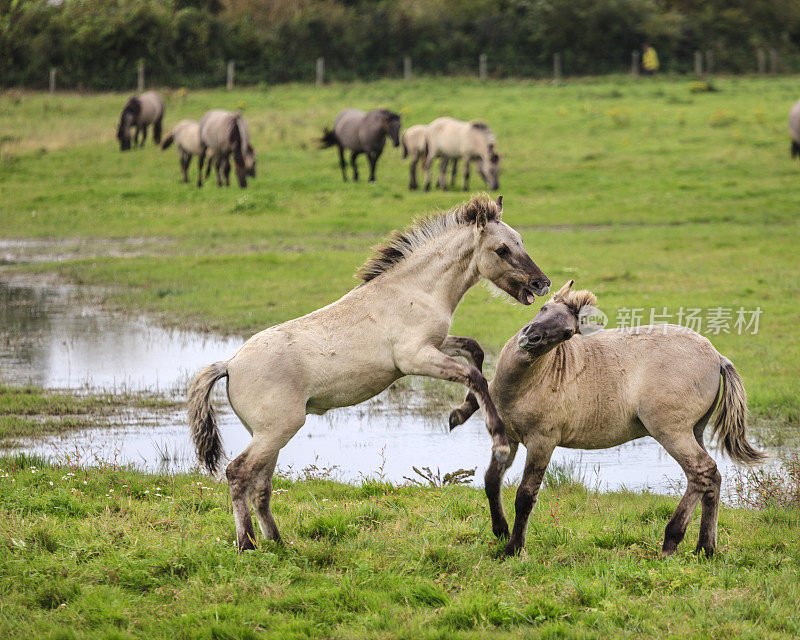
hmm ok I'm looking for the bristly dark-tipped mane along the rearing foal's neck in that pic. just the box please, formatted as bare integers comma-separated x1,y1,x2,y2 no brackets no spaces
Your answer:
354,193,501,282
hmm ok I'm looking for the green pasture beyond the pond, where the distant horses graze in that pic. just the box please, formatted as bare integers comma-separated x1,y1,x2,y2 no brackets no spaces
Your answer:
0,77,800,426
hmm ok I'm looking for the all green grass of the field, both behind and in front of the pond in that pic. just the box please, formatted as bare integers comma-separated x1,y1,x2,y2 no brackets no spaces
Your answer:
0,77,800,640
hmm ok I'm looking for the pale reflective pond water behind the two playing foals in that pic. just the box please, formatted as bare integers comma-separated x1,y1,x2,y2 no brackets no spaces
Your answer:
0,283,780,491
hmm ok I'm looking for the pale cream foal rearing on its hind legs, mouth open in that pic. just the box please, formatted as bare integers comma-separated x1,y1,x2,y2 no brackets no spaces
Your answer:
188,194,550,550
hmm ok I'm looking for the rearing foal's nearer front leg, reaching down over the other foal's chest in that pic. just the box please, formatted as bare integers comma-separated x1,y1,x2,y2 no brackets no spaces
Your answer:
397,345,511,463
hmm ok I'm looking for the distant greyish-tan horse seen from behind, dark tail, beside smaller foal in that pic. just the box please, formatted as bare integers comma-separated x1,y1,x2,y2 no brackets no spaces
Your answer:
197,109,256,189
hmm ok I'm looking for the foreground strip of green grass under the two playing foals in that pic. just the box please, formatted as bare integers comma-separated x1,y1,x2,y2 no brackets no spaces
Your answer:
0,458,800,640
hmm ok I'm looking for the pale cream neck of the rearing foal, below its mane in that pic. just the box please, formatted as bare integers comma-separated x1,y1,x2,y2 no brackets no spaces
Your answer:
387,225,480,314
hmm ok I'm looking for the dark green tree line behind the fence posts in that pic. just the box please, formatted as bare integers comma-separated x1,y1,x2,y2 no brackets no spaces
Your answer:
0,0,800,89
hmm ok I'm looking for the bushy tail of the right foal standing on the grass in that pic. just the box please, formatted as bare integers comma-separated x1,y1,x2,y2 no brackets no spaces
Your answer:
713,355,767,464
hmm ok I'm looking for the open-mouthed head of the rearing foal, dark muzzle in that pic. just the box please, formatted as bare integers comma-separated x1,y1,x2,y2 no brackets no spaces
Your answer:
475,196,550,305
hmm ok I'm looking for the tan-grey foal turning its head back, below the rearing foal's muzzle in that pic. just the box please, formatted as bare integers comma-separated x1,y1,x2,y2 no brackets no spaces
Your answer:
450,280,765,557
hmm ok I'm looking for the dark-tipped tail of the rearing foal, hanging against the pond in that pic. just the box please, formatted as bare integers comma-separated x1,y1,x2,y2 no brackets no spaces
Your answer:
186,362,228,474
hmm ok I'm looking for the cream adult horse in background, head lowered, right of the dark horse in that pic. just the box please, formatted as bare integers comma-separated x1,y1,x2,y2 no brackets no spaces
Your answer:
424,117,500,191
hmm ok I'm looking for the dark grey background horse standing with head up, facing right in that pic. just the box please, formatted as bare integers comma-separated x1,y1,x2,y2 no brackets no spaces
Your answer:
320,109,400,182
